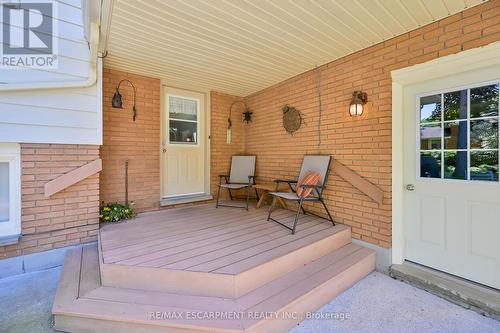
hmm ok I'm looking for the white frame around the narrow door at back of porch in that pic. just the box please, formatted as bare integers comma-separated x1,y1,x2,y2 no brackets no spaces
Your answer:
159,84,212,203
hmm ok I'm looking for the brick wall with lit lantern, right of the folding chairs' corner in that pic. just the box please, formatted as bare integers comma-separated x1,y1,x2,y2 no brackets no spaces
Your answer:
245,0,500,247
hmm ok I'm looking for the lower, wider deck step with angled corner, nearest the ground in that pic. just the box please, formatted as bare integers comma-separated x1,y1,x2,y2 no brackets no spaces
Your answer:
52,244,375,333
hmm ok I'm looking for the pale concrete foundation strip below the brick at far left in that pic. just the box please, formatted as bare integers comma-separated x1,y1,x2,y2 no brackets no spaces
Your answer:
0,242,95,279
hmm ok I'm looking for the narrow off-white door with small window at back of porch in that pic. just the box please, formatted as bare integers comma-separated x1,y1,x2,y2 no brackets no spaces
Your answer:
162,87,207,198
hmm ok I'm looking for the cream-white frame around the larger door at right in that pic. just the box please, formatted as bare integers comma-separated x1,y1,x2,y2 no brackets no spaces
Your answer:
391,42,500,264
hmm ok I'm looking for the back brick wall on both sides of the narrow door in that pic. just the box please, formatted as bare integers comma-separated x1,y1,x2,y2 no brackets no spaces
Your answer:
100,69,245,212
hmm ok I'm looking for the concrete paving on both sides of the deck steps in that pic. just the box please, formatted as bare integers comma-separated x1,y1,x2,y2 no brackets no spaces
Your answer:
0,268,500,333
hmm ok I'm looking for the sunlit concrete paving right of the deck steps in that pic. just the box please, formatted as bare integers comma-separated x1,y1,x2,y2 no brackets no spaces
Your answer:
290,272,500,333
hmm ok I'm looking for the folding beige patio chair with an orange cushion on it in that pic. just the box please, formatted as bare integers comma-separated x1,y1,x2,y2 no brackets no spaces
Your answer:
267,155,335,234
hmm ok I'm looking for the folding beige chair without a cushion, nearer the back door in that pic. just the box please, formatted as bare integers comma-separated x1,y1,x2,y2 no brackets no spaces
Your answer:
215,156,258,210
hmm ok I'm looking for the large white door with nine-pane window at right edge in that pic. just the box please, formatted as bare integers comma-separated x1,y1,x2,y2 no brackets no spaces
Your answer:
403,76,500,289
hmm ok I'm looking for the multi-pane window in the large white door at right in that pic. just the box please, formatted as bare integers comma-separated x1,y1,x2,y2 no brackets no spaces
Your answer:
419,82,500,182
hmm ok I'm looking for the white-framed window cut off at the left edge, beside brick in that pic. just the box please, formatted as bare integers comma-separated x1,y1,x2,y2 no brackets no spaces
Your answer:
0,143,21,238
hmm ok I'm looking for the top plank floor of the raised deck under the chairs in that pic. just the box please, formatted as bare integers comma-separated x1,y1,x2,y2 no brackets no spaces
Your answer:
100,204,346,274
